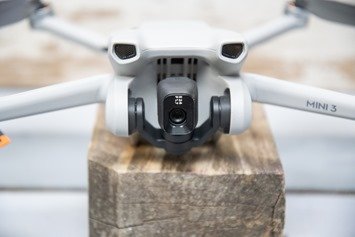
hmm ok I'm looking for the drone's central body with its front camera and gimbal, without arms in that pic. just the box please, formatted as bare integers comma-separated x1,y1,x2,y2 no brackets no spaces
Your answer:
106,22,251,153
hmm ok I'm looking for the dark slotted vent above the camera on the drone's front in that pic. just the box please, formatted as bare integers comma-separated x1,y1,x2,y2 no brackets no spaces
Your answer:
157,58,198,82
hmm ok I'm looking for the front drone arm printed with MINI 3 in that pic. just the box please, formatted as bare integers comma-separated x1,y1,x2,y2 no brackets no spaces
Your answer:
242,74,355,120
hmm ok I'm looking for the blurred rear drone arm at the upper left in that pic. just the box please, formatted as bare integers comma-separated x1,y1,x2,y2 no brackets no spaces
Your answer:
30,6,107,52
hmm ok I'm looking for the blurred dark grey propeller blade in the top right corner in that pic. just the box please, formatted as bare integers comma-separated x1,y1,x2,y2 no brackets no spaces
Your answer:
295,0,355,25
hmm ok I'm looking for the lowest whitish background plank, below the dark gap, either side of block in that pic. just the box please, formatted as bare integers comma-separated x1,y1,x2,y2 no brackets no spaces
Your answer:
0,191,355,237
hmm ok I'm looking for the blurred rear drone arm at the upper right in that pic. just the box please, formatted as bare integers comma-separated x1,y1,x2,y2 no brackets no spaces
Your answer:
244,4,308,48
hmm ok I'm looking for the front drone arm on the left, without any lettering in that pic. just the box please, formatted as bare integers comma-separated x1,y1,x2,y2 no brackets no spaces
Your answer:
0,75,112,121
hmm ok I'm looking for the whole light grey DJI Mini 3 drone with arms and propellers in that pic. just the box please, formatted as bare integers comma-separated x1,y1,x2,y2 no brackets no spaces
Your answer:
0,0,355,155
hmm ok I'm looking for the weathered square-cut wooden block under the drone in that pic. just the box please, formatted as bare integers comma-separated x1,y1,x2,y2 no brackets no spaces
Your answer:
89,105,285,237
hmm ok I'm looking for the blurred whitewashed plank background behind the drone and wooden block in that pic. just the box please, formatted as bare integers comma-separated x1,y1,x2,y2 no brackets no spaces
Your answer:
0,0,355,237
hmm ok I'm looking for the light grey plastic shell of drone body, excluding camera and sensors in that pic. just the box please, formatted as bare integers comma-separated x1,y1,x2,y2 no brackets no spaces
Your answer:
106,22,251,136
